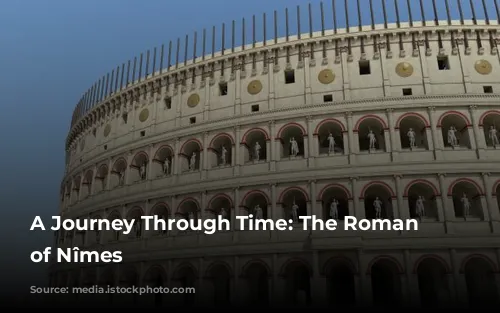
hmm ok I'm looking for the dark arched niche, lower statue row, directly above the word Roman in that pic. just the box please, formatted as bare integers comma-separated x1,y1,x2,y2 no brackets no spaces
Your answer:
363,183,394,219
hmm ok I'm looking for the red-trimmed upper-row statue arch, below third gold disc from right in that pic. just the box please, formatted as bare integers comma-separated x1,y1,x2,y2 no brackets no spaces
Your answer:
314,118,346,154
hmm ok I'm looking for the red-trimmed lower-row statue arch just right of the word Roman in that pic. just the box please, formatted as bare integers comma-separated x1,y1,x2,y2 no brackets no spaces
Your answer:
403,179,440,220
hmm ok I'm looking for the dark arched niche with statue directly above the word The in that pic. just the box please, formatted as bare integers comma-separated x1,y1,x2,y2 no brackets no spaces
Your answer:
321,185,350,220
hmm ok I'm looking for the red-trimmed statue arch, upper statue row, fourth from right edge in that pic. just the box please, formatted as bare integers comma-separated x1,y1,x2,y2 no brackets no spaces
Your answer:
354,114,388,151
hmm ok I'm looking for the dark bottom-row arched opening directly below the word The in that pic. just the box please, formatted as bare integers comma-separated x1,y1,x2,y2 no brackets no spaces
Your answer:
326,260,356,307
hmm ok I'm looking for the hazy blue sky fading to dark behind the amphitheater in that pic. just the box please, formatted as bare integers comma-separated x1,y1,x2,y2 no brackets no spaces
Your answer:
0,0,486,298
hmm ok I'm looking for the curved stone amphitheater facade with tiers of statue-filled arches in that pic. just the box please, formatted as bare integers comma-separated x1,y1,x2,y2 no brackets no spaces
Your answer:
51,2,500,306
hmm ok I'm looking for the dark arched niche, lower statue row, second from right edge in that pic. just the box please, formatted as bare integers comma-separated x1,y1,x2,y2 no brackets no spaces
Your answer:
451,180,483,220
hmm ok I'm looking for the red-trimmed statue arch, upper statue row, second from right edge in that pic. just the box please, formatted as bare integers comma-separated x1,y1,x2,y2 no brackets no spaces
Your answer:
437,111,471,149
